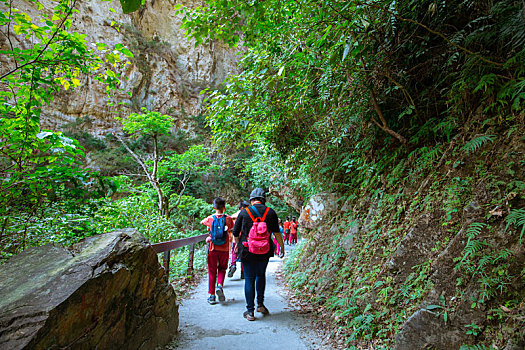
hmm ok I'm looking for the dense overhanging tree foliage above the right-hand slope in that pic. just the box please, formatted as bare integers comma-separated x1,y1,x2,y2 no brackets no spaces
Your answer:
178,0,525,197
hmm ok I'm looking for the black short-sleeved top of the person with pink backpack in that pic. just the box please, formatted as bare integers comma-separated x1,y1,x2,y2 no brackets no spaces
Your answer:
232,204,280,261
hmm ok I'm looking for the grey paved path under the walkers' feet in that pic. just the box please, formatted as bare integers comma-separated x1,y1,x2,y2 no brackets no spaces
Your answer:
172,247,327,350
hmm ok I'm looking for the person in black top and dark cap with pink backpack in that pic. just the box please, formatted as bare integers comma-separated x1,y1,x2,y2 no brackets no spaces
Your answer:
233,188,284,321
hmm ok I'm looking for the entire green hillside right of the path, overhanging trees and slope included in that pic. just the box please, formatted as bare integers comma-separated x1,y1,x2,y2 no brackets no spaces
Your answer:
181,0,525,349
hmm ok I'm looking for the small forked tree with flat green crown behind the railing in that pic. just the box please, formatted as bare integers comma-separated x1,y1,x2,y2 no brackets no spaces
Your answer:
117,108,210,218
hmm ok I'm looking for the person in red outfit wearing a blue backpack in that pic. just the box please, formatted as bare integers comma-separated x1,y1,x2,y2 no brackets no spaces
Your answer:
201,197,233,305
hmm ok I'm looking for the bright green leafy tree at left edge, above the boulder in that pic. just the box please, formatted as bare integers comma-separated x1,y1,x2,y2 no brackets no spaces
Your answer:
0,0,133,252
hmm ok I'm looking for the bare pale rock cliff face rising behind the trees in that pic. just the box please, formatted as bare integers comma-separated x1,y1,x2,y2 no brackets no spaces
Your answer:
37,0,238,136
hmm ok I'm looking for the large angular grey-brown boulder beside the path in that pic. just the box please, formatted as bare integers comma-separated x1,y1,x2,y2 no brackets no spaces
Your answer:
0,229,179,349
